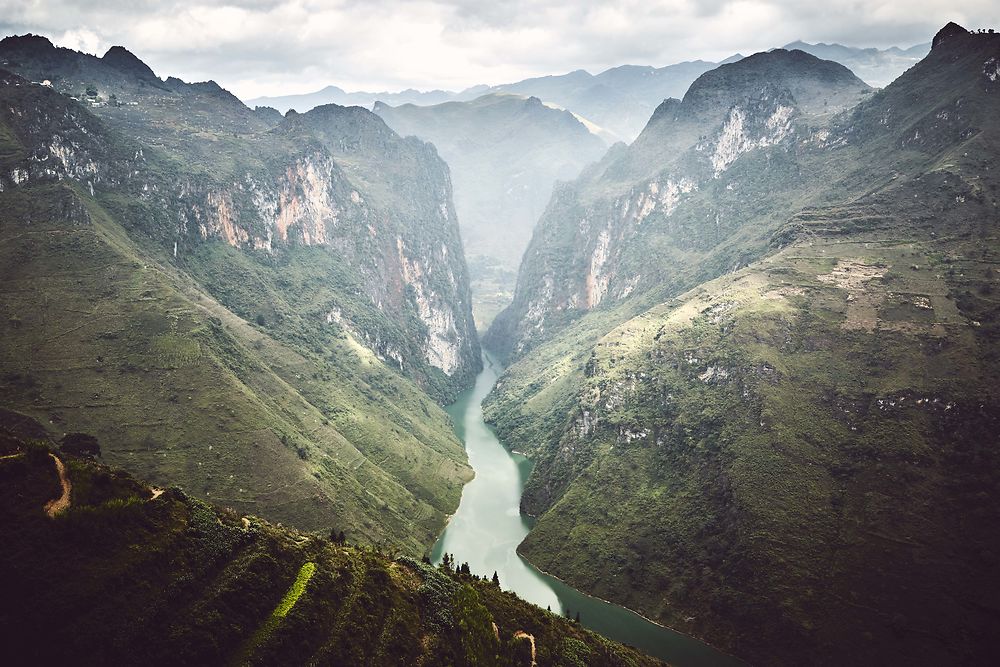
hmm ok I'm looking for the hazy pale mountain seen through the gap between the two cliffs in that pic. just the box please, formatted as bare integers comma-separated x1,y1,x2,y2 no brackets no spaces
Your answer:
374,95,606,330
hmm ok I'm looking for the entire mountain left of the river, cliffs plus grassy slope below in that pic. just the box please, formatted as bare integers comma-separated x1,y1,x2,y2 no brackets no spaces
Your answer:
0,38,480,554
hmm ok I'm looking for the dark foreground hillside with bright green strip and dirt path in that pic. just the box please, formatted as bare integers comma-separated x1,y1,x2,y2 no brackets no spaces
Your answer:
0,428,659,667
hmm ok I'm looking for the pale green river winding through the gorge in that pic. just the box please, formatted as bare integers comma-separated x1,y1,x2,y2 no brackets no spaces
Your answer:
431,354,745,667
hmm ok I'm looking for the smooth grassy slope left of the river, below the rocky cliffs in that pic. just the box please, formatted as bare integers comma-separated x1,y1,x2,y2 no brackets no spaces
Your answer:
0,184,471,553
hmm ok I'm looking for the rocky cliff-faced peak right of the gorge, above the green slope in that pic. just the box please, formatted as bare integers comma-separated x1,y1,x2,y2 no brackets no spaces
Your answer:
486,50,869,356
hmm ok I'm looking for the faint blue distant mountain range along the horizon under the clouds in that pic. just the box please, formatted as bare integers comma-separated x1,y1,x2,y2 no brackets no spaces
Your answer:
247,41,930,142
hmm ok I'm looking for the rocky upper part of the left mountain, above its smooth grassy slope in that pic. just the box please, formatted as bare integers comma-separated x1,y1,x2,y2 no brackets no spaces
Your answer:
0,36,480,403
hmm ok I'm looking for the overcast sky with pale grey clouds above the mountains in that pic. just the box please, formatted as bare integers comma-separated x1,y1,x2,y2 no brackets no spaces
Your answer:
0,0,1000,99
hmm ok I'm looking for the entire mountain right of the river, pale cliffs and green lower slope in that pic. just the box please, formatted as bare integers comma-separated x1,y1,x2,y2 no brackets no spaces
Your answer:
487,25,1000,664
